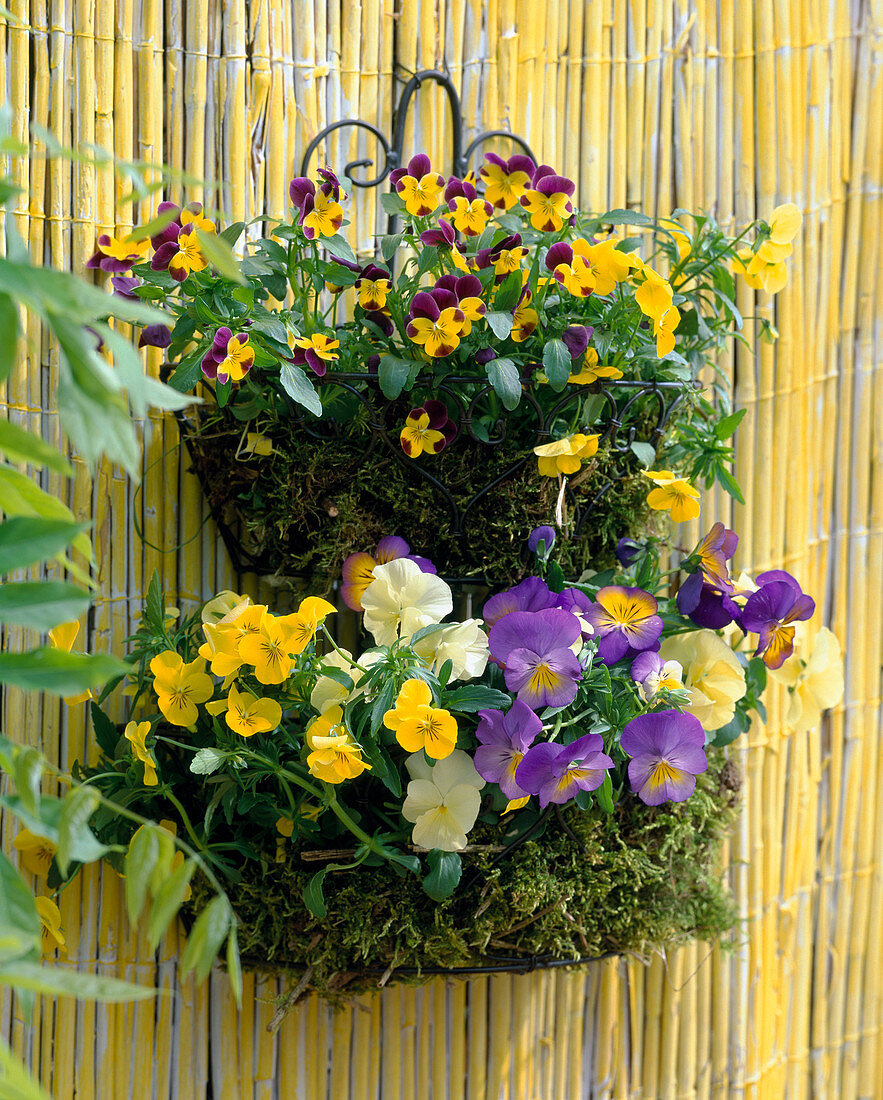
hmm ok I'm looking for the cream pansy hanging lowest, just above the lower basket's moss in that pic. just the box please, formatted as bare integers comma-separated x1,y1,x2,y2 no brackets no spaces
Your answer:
401,749,485,851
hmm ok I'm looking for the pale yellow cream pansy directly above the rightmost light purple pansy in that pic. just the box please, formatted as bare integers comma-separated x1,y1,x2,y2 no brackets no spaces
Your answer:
659,630,746,732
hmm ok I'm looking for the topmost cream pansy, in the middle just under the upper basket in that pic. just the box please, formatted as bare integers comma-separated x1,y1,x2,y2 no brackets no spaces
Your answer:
362,558,454,646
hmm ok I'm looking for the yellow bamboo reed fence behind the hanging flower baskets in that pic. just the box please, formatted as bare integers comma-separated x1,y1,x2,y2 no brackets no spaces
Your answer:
0,0,883,1100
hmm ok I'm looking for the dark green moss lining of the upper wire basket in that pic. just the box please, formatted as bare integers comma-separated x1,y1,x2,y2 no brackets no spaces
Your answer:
184,414,648,584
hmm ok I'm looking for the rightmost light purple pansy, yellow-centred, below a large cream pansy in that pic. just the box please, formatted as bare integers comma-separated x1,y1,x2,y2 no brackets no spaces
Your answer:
619,711,708,806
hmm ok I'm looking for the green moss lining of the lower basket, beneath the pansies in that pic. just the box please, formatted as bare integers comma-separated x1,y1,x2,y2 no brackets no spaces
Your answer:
191,750,739,998
